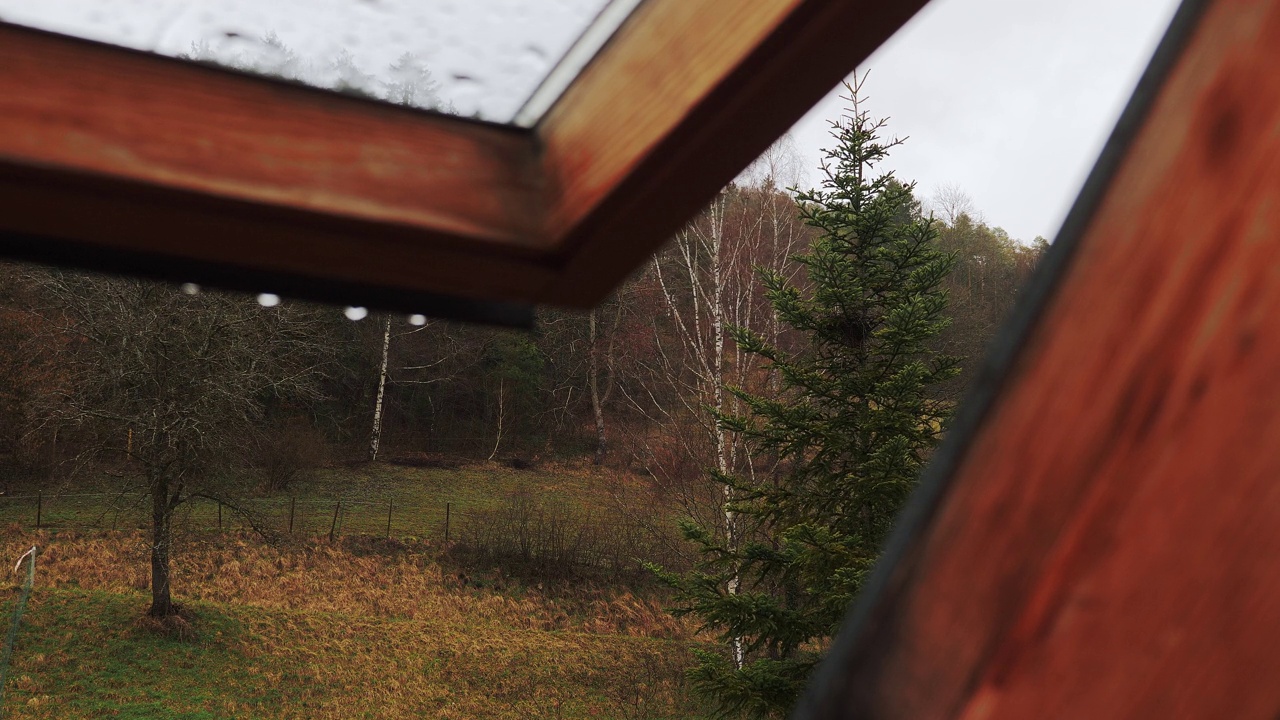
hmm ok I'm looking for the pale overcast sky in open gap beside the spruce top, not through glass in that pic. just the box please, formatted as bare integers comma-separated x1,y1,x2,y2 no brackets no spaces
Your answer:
792,0,1178,241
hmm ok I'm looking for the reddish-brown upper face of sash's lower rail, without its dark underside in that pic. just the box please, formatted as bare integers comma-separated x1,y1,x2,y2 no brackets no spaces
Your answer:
0,24,539,246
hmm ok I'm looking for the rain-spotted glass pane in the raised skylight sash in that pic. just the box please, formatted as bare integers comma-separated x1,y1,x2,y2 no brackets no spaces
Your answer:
0,0,619,124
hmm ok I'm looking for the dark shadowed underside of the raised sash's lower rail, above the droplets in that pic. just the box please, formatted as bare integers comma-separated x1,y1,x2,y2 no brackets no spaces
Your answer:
0,163,553,303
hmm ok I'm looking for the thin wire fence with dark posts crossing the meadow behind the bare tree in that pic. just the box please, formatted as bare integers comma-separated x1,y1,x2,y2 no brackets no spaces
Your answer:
0,492,687,577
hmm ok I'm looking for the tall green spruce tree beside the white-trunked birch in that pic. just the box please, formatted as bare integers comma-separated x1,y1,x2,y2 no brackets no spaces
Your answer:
663,86,957,717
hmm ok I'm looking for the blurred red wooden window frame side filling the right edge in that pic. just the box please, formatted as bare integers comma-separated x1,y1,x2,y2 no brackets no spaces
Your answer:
803,0,1280,720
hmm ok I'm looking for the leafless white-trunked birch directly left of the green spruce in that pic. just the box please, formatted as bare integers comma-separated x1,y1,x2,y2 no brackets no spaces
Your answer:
643,181,805,661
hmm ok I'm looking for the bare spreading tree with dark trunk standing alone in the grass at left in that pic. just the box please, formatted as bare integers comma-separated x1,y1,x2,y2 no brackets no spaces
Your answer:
28,270,329,618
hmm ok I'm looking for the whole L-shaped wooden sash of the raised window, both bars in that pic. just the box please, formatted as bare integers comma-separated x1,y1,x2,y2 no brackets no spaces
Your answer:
0,0,924,324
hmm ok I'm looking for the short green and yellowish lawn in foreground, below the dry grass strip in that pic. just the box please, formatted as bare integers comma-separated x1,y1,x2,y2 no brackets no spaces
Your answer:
4,589,706,720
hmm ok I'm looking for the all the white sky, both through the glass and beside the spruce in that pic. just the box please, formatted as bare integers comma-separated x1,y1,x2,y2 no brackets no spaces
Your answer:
0,0,1176,241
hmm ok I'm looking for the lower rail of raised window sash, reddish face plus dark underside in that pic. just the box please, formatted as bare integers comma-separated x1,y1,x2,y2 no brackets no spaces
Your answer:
0,24,548,297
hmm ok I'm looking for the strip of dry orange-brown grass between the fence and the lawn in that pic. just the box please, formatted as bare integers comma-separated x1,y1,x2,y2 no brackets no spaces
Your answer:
0,528,691,639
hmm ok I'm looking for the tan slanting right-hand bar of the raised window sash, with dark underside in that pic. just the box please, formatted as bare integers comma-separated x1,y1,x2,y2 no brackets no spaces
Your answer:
535,0,924,306
